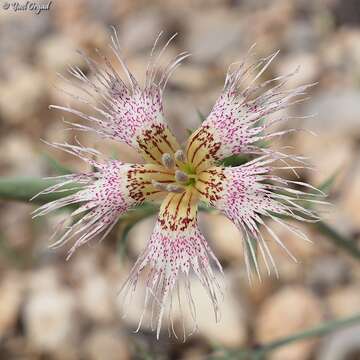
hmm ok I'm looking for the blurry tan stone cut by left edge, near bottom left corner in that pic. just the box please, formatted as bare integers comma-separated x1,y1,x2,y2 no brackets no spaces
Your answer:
0,272,22,341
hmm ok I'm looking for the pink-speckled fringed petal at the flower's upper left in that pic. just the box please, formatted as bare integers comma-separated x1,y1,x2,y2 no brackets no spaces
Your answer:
51,32,188,164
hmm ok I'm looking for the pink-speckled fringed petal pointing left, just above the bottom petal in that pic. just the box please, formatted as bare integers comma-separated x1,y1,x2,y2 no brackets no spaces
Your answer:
34,144,168,257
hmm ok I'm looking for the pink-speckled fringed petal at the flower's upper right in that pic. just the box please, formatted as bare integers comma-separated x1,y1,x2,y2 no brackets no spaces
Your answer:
187,53,314,171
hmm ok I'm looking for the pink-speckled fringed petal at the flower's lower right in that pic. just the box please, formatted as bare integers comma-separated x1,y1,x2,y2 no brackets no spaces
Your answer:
196,156,321,278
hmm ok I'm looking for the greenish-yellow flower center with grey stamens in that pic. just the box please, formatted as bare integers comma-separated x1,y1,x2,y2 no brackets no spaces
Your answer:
152,150,197,193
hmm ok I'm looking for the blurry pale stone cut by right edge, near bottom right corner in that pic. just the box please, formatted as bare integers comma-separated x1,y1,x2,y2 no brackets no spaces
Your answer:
327,284,360,318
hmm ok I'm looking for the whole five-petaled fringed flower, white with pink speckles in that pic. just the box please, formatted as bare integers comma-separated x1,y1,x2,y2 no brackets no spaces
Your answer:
35,32,316,336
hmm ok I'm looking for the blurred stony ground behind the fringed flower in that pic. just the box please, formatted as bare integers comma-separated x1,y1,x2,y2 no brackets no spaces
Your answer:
0,0,360,360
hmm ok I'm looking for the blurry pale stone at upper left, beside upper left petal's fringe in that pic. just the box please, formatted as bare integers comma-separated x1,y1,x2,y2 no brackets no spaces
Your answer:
37,35,84,73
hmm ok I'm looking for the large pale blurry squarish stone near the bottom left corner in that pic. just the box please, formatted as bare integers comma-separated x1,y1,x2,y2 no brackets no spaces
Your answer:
24,288,80,351
